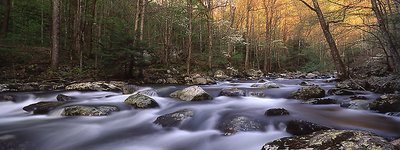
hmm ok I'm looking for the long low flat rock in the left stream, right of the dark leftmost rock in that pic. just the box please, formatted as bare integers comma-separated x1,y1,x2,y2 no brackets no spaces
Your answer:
62,106,119,116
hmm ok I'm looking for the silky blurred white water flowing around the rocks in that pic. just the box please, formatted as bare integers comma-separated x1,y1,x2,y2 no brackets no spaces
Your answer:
0,80,400,150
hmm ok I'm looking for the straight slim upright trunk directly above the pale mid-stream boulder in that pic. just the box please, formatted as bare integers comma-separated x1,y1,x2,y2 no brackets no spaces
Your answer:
186,0,193,75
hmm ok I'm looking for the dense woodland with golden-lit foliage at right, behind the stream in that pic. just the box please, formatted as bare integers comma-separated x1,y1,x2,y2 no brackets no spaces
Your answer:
0,0,400,79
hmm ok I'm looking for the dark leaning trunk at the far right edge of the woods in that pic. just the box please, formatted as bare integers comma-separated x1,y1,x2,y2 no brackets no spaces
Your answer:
371,0,400,73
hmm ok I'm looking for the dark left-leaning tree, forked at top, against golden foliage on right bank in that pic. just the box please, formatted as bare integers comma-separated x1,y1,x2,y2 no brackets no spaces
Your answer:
299,0,348,79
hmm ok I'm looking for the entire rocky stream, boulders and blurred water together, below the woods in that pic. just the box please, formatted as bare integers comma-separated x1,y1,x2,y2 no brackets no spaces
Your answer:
0,75,400,150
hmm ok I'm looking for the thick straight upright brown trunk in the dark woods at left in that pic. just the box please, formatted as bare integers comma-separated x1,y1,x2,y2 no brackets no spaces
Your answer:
51,0,61,69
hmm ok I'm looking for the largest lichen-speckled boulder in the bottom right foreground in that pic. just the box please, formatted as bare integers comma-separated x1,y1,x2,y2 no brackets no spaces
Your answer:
262,130,396,150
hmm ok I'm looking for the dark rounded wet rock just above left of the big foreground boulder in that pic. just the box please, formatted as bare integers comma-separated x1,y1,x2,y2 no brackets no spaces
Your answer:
217,116,265,136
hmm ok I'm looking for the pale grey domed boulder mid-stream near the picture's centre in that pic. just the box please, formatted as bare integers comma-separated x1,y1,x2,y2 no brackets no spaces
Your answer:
170,86,212,101
